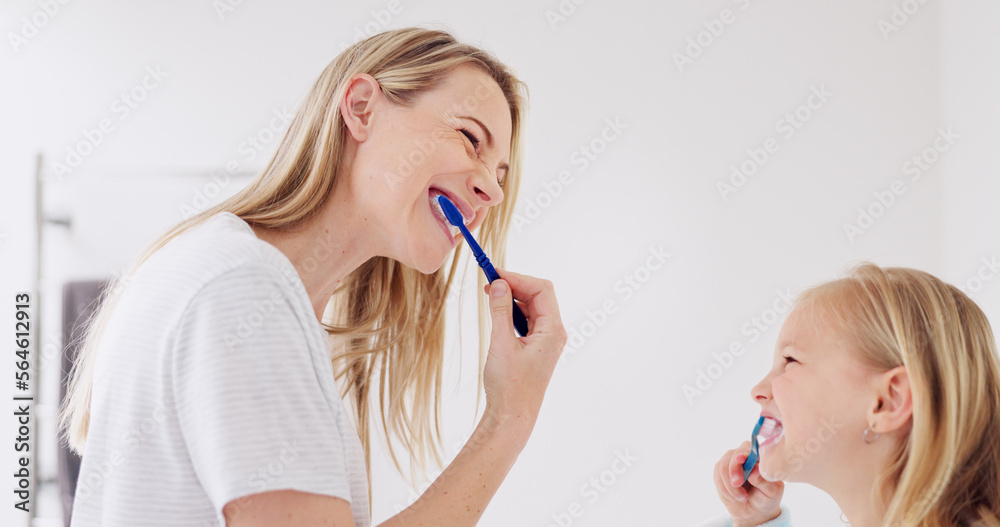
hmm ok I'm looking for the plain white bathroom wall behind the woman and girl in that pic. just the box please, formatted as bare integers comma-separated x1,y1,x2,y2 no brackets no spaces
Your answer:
0,0,1000,527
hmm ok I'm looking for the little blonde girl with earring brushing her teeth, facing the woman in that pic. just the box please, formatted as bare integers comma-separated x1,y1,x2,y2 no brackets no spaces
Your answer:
715,264,1000,527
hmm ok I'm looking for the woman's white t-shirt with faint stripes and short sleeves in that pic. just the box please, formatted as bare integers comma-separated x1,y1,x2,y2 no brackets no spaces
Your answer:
72,212,370,527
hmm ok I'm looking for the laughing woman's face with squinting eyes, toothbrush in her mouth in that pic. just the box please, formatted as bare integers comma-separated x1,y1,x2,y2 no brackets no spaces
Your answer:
351,65,511,273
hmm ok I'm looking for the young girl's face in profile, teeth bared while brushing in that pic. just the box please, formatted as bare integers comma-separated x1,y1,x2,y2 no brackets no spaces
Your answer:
751,304,875,488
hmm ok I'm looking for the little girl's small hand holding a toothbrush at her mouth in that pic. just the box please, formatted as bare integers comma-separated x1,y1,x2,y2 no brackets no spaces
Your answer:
715,441,785,527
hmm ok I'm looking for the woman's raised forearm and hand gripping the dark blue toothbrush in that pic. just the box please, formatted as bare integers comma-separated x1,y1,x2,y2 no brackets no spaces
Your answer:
382,269,566,527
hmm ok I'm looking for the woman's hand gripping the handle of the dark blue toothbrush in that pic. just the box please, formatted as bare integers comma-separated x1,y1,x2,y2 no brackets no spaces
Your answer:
483,269,566,441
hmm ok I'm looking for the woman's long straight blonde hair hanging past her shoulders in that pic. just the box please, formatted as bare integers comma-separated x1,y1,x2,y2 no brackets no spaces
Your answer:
60,28,527,482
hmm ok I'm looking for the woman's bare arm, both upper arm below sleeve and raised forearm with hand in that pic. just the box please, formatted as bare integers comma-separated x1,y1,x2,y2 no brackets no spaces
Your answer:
224,270,566,527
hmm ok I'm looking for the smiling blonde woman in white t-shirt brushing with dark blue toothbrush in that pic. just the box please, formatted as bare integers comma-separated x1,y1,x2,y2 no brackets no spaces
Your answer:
62,28,566,527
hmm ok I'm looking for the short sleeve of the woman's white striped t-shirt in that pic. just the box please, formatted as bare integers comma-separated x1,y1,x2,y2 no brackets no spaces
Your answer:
172,263,353,518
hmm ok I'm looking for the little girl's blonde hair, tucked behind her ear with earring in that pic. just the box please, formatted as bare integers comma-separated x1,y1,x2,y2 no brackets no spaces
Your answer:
798,264,1000,527
